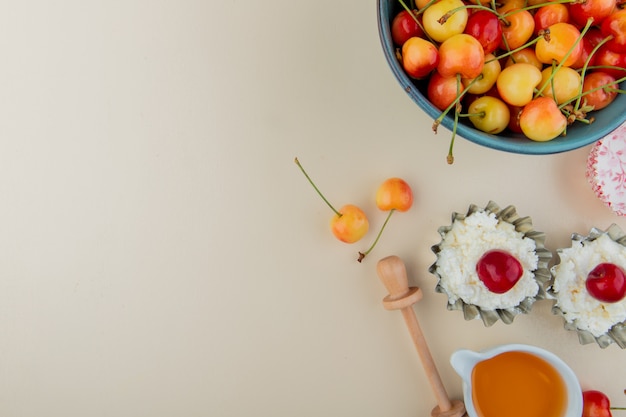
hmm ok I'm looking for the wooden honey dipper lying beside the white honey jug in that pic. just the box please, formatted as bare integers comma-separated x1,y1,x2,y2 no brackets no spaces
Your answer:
376,256,465,417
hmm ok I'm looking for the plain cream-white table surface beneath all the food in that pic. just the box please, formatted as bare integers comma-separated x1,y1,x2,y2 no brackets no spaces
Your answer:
0,0,626,417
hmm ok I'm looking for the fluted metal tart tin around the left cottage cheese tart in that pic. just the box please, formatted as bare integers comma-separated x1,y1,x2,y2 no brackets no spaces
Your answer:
428,201,552,327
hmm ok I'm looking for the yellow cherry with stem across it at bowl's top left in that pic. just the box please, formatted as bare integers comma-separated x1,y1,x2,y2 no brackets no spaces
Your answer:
422,0,468,43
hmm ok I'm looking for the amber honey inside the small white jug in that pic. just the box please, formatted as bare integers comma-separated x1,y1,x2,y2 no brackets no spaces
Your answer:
472,351,567,417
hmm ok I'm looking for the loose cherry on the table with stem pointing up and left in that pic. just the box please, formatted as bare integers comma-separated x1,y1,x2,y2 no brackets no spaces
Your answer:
294,158,369,243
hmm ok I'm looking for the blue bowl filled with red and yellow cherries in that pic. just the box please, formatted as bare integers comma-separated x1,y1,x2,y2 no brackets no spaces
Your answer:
377,0,626,163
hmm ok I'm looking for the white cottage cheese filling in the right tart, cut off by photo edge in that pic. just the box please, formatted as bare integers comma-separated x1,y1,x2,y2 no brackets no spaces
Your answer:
552,234,626,337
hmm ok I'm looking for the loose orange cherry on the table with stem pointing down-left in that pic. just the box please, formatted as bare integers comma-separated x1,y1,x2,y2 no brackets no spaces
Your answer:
357,177,413,262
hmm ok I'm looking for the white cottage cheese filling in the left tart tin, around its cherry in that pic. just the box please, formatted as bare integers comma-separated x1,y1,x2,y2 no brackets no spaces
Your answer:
436,211,539,310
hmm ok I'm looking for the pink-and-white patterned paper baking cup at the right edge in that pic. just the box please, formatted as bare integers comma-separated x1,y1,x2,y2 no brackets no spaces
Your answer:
585,123,626,216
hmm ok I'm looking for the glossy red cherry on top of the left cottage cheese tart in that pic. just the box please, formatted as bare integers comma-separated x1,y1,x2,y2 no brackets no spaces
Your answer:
476,249,524,294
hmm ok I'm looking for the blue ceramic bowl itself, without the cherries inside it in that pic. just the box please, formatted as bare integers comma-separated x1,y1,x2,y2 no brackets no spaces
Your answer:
377,0,626,155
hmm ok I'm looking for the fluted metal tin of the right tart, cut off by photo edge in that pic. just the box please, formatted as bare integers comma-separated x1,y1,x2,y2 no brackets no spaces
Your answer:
548,224,626,349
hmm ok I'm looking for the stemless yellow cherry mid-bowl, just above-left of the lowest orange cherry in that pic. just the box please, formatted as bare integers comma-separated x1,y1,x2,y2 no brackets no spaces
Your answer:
496,62,541,107
